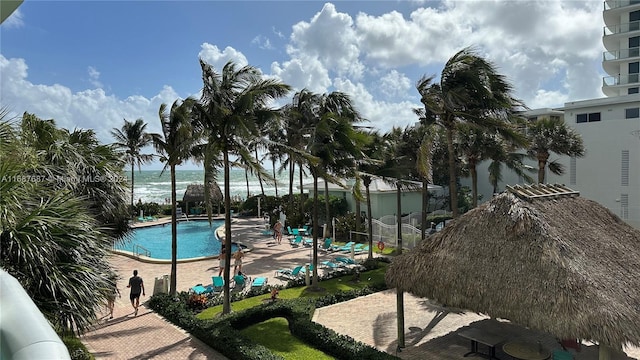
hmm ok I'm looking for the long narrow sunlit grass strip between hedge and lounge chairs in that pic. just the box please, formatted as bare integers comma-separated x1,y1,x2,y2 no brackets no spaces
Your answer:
197,262,387,319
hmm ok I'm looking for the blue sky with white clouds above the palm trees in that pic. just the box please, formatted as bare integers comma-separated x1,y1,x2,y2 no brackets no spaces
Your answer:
0,0,604,168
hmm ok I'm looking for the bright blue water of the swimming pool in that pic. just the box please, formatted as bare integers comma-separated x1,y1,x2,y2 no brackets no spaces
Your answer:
115,220,235,260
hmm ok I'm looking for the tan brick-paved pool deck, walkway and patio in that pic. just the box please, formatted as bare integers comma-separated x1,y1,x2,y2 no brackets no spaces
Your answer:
82,218,640,360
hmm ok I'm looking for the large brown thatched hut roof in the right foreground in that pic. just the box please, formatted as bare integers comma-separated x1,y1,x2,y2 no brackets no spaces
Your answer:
386,185,640,349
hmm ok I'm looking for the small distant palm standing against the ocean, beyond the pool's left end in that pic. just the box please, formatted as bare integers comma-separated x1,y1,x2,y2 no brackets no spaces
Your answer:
111,119,153,211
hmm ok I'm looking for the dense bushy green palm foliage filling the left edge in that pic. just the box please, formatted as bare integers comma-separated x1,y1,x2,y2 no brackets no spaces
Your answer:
0,113,128,333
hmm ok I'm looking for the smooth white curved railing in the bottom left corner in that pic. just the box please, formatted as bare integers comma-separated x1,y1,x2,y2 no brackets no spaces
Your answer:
0,269,71,360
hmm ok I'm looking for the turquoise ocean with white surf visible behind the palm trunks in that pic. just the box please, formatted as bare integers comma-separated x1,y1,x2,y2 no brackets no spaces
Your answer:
125,169,310,204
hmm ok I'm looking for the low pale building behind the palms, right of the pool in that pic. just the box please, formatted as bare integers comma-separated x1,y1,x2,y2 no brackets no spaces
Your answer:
304,178,446,219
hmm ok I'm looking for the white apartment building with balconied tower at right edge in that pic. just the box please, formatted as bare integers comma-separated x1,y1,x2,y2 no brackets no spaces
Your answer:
463,0,640,228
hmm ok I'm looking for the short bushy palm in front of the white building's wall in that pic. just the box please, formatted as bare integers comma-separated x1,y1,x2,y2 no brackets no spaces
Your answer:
527,117,585,184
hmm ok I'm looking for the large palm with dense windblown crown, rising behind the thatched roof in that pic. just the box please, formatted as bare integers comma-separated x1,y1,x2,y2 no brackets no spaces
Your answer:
416,48,523,217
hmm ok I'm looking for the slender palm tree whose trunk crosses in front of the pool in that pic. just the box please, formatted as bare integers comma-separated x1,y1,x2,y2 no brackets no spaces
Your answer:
151,98,199,295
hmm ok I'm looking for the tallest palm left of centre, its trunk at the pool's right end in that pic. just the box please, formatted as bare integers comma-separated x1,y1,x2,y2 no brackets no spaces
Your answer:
191,60,290,314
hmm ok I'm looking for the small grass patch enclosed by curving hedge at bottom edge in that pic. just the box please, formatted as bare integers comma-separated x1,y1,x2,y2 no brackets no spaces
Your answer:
241,317,333,360
